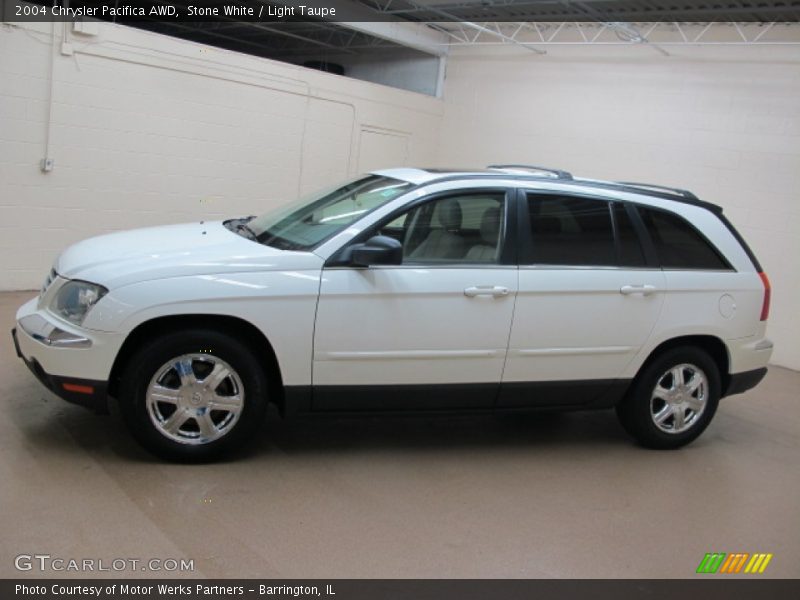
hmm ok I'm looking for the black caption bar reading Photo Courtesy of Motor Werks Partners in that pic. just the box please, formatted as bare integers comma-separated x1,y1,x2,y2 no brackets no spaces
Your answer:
0,576,800,600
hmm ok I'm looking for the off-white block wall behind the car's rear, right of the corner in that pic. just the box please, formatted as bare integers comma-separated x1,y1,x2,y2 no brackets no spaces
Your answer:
439,46,800,369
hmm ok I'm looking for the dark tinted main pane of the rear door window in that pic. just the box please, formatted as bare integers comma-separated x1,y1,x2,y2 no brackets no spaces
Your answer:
528,195,618,266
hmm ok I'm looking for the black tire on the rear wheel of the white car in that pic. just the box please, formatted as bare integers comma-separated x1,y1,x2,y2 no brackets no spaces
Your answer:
617,346,721,450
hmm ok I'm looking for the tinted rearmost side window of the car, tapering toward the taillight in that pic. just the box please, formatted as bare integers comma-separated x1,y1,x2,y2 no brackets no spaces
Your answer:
637,206,731,270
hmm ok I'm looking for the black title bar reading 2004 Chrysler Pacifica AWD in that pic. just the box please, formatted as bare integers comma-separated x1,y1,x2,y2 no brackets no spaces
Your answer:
6,0,800,23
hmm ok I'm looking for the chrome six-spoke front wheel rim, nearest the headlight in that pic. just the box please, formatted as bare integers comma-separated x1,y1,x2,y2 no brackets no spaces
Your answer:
146,354,244,445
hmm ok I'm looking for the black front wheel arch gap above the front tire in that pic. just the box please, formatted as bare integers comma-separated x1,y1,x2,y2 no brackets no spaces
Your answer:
108,314,285,415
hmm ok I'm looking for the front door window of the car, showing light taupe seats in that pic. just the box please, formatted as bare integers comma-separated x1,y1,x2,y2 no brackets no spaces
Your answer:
380,192,505,264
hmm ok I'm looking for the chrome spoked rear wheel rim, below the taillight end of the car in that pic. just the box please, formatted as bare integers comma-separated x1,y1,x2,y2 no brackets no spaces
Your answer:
650,363,709,433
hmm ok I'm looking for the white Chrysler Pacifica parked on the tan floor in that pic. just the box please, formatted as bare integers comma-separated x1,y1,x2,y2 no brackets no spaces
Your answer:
13,165,772,461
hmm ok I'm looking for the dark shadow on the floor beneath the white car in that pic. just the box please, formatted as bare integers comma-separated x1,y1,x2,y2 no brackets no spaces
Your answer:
6,386,631,462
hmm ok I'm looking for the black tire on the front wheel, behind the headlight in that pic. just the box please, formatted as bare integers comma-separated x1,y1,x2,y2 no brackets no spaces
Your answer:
119,329,268,462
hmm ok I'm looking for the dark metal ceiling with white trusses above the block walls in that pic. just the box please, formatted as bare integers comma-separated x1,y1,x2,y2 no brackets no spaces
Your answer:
26,0,800,89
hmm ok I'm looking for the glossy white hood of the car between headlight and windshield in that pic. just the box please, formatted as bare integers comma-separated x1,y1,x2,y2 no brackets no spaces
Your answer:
55,221,323,289
